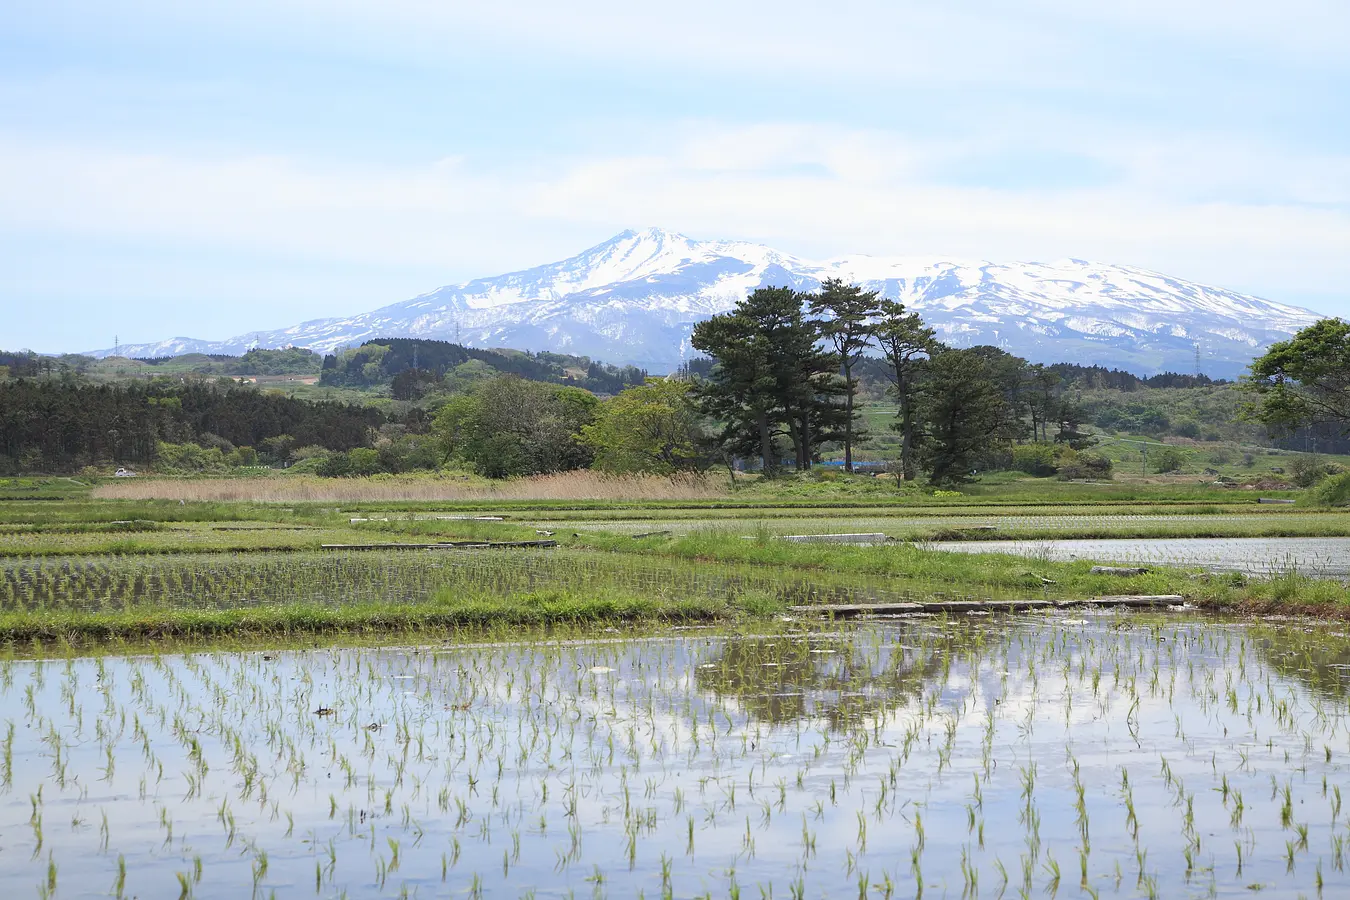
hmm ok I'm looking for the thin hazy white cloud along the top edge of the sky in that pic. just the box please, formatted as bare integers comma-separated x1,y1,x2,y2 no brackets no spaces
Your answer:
28,0,1350,88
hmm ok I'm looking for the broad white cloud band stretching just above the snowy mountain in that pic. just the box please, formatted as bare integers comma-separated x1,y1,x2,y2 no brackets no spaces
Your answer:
0,123,1350,307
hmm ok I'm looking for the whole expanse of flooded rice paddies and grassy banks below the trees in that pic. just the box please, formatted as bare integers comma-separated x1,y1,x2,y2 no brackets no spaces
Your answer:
0,479,1350,897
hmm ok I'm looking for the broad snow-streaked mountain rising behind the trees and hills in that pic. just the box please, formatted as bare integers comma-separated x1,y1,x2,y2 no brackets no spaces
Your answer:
95,228,1320,378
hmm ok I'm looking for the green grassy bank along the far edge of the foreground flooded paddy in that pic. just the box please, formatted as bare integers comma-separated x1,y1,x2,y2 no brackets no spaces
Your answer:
0,536,1350,644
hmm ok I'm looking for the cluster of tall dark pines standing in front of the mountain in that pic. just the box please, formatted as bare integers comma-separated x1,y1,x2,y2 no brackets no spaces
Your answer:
687,279,1091,483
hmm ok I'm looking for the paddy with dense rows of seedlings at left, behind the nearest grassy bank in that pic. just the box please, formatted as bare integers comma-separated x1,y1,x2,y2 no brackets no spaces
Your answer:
0,546,1044,611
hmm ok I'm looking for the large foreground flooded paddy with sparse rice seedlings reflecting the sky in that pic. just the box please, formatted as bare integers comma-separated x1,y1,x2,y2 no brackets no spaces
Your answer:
0,615,1350,899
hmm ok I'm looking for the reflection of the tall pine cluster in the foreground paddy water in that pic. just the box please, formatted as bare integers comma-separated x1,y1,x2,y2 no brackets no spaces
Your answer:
695,629,961,730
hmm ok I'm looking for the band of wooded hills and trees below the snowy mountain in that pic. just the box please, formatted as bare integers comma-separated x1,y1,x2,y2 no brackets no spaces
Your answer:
0,299,1333,483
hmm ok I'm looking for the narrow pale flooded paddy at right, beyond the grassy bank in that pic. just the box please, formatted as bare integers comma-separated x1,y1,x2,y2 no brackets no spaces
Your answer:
929,537,1350,578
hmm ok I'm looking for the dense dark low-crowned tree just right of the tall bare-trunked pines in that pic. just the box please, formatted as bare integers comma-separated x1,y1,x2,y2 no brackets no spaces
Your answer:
919,348,1010,484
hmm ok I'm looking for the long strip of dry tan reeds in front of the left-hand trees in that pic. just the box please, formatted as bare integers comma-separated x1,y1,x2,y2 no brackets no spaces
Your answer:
93,471,726,503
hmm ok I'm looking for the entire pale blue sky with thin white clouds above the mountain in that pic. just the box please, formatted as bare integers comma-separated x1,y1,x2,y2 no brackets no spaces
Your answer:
0,0,1350,351
